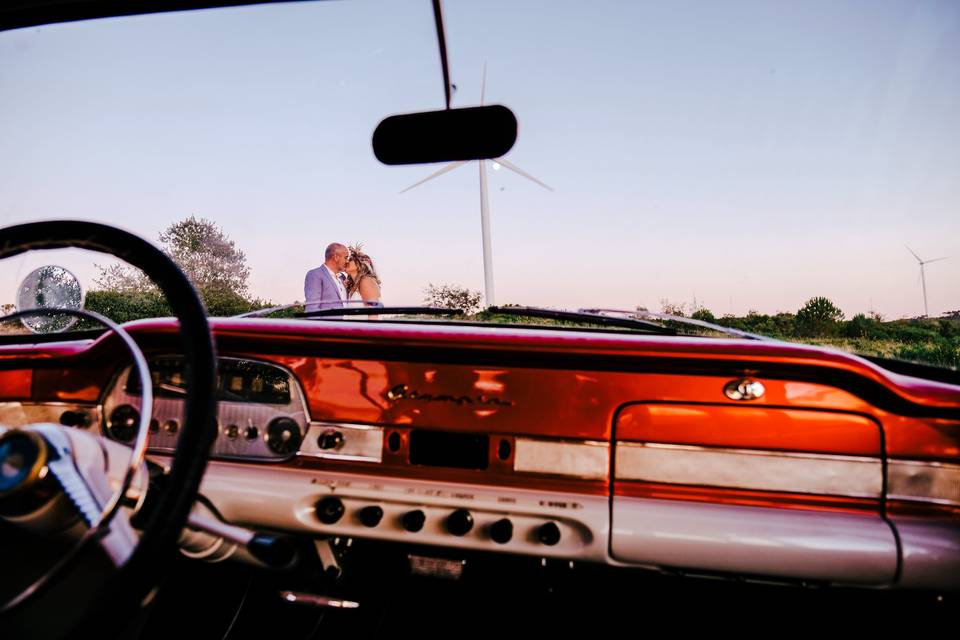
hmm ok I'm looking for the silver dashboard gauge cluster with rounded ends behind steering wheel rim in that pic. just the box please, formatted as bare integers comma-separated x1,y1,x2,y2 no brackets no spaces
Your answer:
102,356,308,461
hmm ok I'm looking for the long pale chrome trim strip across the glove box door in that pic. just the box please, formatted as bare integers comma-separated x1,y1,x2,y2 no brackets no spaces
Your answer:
616,442,883,498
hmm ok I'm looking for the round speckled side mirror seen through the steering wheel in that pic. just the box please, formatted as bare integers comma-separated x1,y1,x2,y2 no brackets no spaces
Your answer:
17,265,83,333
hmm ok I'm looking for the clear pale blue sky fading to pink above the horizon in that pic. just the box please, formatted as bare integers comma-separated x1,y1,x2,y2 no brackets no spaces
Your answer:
0,0,960,318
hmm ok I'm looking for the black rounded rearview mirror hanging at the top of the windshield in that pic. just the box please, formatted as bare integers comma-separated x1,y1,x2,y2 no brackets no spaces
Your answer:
373,105,517,165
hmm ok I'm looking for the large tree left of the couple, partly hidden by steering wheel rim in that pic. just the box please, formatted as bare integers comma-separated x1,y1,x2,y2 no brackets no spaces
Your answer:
88,216,265,320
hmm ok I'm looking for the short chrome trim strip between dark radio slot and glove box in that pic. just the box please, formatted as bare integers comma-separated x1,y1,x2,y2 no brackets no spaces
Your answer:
513,438,610,480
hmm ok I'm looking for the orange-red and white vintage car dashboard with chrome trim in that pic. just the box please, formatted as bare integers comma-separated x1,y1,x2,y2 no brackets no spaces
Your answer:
0,319,960,590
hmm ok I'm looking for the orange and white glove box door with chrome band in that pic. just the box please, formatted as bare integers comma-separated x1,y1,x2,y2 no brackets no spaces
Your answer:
610,402,897,585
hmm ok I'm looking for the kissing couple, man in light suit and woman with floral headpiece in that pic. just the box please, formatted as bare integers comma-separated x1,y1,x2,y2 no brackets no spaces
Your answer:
303,242,381,312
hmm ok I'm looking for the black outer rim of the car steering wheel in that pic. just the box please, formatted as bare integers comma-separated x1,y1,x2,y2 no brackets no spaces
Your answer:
0,221,217,629
